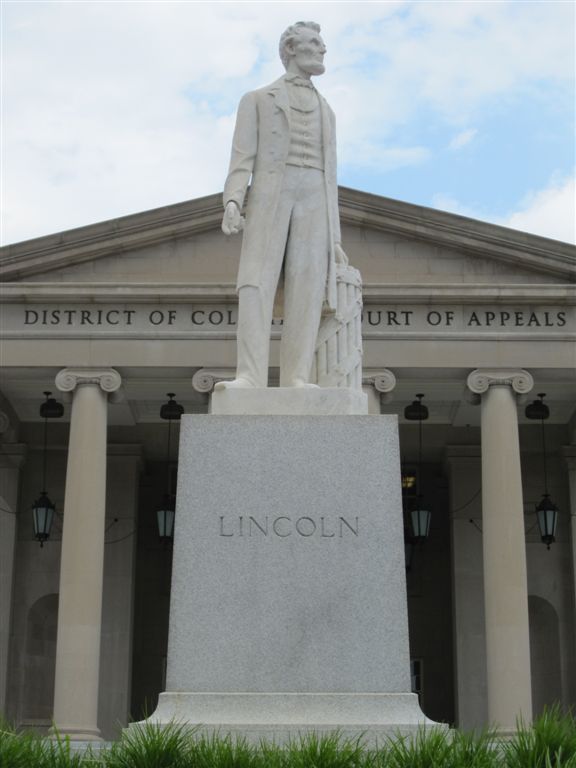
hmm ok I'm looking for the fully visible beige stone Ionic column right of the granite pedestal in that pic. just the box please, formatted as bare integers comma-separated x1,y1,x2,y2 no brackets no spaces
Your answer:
468,369,533,731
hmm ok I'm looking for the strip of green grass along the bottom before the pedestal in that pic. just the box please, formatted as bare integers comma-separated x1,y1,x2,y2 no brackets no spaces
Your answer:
0,707,576,768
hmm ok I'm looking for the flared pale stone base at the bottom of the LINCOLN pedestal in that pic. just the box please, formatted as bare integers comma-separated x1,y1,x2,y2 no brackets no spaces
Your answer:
130,692,438,744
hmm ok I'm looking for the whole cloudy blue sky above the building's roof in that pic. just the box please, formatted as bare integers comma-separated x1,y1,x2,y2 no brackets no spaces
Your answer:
2,0,576,243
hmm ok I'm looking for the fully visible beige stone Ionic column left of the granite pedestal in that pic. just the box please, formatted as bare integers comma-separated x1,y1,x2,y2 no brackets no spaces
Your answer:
54,368,121,741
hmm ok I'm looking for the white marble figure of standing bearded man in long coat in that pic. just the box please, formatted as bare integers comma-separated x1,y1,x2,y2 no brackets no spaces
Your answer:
217,22,347,388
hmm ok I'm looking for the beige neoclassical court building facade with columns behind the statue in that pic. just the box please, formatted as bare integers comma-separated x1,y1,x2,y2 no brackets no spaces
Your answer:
0,188,576,738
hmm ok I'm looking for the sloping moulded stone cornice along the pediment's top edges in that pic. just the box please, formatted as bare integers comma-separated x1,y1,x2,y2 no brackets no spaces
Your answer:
0,187,576,282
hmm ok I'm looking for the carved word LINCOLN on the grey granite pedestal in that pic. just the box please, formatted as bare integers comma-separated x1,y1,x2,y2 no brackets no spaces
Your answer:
218,515,360,539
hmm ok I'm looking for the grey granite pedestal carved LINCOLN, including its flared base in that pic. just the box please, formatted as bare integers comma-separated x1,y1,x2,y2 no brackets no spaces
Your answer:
144,415,430,741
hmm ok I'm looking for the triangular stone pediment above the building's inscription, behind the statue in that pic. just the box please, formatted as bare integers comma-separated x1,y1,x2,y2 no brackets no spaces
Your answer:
0,188,576,286
